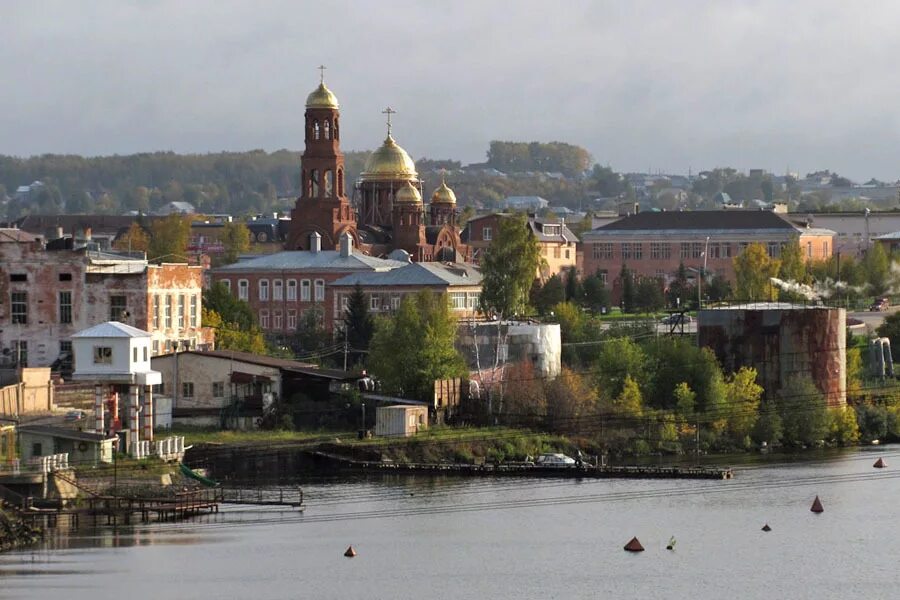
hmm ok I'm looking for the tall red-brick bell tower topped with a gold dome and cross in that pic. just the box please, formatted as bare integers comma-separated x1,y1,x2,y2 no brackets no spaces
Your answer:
287,66,358,250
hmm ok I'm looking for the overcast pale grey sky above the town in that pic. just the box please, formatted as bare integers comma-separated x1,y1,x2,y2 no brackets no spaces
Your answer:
0,0,900,180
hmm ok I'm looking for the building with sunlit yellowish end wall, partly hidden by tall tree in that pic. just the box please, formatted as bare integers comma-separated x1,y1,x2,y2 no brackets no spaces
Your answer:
463,213,578,280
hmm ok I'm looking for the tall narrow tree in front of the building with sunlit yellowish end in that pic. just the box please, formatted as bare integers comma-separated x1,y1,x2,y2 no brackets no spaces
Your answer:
481,214,542,318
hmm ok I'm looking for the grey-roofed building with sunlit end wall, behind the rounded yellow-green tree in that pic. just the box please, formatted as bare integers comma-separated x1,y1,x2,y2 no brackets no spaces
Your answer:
325,262,481,329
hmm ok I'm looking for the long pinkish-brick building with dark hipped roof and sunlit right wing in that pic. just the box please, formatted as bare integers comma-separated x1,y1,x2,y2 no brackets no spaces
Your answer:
583,211,835,298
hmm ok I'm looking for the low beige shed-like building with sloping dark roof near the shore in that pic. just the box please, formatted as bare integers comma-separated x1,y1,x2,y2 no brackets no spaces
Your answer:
152,350,358,429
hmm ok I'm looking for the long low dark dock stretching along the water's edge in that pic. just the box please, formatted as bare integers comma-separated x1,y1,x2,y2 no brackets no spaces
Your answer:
315,452,734,479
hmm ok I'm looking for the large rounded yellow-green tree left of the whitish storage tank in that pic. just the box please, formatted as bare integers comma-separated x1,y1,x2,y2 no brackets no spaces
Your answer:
369,290,466,400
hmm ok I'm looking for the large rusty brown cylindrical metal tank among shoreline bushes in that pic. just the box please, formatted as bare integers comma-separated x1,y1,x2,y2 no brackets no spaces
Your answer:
697,303,847,407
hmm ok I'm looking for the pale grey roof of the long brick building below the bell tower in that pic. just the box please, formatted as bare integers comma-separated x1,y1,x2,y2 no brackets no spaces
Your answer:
212,250,406,273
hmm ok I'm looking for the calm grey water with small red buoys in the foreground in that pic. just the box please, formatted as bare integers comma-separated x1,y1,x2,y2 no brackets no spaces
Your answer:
0,447,900,600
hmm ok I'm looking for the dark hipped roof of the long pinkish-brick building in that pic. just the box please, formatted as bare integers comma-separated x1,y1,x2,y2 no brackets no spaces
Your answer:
585,210,798,236
